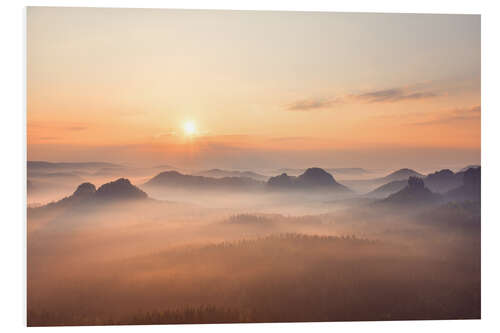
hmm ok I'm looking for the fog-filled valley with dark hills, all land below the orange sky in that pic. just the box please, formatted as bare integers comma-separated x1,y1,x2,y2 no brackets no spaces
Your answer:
27,161,481,326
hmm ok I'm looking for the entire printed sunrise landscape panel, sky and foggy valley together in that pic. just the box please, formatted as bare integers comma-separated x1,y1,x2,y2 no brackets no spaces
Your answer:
26,7,481,326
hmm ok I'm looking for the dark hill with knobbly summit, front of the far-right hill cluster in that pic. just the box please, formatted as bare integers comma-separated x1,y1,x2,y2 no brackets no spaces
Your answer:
379,177,441,206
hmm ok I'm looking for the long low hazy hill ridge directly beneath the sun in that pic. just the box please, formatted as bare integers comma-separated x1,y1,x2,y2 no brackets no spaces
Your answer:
144,171,264,190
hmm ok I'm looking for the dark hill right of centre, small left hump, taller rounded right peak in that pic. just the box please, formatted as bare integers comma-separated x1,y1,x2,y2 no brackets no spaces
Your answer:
267,168,350,192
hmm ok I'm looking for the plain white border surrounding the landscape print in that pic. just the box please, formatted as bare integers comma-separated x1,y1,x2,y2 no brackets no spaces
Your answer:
0,0,500,332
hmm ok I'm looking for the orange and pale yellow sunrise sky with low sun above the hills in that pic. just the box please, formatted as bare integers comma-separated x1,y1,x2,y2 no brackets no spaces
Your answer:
27,7,481,171
